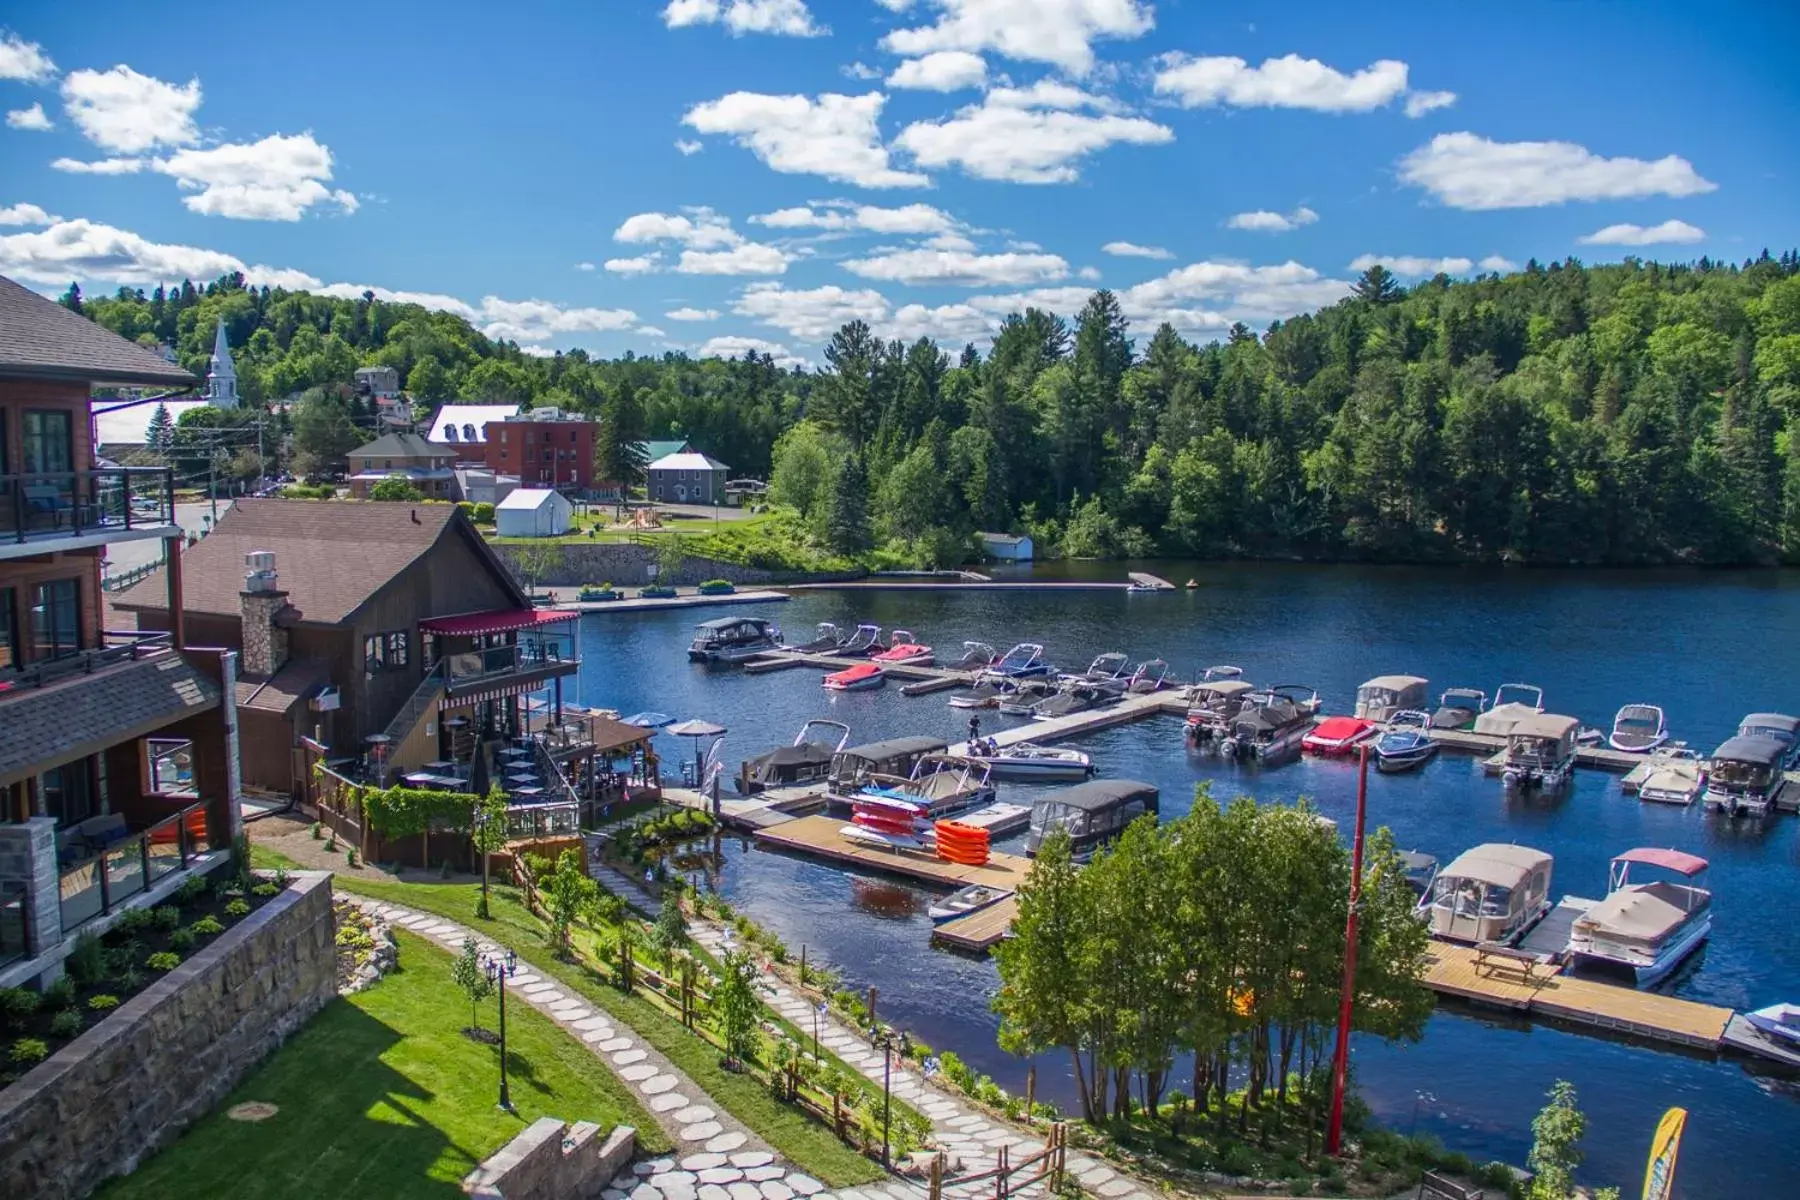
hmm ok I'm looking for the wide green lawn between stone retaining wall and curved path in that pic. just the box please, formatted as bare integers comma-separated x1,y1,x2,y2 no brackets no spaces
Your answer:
101,930,670,1200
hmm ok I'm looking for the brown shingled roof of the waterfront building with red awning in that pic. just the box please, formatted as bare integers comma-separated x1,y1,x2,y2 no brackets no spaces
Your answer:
112,498,529,624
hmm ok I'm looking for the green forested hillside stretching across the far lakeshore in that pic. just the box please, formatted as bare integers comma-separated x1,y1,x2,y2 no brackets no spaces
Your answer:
85,252,1800,563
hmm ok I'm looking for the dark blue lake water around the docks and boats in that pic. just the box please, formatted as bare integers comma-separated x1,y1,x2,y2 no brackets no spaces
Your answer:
580,563,1800,1200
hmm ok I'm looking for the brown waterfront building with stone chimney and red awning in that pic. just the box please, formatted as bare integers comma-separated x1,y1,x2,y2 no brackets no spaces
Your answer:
113,498,580,799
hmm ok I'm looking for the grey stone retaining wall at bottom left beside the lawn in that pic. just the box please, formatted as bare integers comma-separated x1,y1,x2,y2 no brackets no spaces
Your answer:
0,871,337,1200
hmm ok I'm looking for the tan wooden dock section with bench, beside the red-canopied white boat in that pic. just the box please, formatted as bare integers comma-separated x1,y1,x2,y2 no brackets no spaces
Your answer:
1426,941,1732,1051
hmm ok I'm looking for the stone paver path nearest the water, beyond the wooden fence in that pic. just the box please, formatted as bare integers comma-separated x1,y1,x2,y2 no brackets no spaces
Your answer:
590,864,1157,1200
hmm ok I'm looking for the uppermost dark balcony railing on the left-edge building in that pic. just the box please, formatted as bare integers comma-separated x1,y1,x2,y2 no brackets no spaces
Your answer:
0,466,175,542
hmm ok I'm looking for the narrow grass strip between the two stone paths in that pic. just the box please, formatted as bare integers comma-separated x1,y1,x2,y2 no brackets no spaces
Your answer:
337,878,882,1187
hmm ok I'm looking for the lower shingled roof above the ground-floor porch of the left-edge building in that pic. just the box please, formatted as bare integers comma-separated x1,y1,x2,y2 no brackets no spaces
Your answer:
0,653,220,786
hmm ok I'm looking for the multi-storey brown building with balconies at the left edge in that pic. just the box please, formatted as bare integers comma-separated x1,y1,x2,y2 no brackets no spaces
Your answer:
0,271,238,988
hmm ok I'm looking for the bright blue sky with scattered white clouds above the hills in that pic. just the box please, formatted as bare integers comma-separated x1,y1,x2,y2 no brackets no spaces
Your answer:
0,0,1800,362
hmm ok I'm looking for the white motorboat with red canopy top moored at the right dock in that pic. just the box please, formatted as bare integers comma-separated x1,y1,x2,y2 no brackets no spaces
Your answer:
1570,847,1712,988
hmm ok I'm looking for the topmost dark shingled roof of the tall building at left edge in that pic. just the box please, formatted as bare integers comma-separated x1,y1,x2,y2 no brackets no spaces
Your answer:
0,275,198,387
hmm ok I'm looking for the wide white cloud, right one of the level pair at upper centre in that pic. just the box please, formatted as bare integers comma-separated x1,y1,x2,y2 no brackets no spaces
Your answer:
895,81,1175,184
